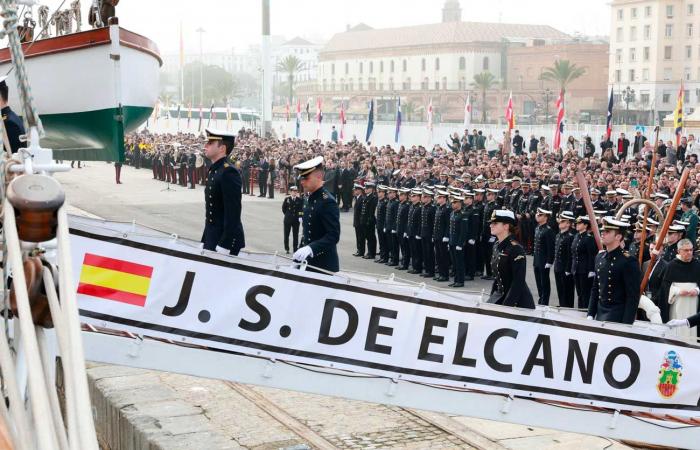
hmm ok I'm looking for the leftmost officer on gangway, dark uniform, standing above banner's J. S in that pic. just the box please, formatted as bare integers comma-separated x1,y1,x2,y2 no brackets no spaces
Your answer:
201,129,245,255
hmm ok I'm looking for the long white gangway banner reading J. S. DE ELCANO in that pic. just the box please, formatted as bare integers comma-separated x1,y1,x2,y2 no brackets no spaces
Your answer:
71,219,700,416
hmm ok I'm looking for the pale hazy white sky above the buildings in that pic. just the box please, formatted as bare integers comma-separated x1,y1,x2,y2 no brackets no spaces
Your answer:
35,0,610,54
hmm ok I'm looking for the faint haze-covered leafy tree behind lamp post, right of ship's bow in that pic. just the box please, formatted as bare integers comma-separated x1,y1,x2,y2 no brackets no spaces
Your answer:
184,62,236,108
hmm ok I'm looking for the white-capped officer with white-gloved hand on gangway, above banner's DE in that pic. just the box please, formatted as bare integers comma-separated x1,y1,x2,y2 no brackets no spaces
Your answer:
293,156,340,272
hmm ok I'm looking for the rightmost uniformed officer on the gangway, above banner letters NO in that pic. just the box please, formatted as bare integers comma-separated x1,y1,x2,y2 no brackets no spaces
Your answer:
588,217,642,325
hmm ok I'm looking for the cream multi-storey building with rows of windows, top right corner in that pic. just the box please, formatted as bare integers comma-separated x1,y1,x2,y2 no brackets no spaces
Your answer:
608,0,700,124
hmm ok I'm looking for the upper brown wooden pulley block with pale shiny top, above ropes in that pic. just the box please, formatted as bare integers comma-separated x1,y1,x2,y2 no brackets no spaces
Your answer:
7,175,66,242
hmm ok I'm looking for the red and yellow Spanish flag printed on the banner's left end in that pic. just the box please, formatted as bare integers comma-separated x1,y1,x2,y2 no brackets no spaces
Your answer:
78,253,153,306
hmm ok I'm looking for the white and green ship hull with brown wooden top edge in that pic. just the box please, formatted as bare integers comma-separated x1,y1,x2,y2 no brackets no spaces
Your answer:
0,25,162,161
